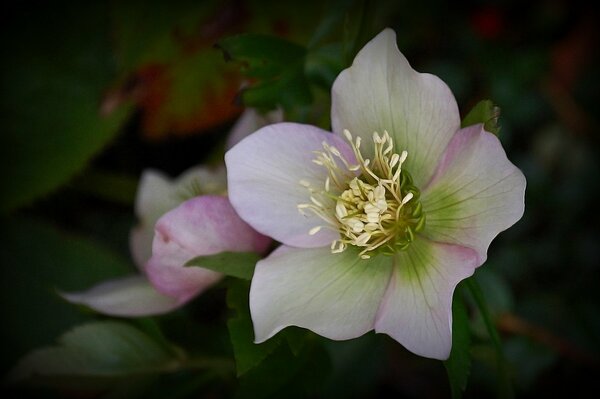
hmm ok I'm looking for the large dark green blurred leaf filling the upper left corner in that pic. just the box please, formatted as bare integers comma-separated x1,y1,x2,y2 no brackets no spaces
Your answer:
0,3,129,212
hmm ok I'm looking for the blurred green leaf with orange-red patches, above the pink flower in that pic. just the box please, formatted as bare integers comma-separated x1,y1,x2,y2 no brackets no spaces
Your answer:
109,0,247,139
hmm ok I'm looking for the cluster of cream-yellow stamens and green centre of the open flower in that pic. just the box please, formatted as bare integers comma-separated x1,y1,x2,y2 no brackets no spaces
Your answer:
298,130,425,259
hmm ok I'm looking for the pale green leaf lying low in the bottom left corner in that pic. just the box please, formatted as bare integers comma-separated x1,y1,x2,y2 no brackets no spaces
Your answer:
9,321,177,382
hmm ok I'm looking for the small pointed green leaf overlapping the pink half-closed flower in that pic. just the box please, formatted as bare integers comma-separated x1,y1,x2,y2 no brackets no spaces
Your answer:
185,252,261,280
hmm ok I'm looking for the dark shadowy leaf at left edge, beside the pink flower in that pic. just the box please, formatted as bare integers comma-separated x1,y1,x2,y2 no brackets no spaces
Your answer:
0,218,132,370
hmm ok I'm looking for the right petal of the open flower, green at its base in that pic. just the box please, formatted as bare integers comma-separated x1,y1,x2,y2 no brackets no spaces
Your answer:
421,125,526,263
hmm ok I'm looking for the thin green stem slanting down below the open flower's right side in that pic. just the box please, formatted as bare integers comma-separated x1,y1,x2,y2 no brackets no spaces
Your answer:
466,277,514,399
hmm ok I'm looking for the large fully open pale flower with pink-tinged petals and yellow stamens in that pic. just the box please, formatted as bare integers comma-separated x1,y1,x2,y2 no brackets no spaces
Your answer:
225,29,525,359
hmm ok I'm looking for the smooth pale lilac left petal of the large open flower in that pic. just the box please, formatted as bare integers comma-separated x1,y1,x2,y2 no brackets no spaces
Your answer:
225,123,355,248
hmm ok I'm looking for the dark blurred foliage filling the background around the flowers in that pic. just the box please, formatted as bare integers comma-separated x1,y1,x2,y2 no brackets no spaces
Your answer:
0,0,600,398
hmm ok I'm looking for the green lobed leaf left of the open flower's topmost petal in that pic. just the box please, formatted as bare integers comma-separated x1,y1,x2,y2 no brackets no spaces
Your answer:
218,34,312,110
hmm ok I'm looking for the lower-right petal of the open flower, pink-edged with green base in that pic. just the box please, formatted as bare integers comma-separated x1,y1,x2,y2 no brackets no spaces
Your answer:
375,238,478,360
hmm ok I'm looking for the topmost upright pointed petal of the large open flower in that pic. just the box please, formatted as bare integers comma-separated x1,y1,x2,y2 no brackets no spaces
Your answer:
331,29,460,187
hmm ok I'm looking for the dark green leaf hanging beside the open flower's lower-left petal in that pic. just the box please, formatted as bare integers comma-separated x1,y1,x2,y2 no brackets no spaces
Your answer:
227,280,281,376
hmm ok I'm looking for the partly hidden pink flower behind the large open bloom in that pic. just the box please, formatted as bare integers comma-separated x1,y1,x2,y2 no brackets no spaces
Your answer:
61,109,282,316
